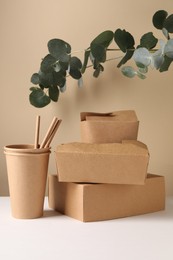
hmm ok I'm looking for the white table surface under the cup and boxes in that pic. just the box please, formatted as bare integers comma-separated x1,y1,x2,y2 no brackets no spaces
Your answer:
0,197,173,260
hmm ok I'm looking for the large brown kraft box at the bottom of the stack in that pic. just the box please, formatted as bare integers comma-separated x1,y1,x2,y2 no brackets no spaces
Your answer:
48,174,165,222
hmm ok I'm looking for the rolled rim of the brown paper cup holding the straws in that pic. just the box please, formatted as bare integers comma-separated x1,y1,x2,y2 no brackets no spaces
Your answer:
4,144,50,154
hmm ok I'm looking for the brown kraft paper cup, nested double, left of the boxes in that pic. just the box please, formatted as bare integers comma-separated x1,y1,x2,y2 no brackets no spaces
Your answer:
4,144,50,219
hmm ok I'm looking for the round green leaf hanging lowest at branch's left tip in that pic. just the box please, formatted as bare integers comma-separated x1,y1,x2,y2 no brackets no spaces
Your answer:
29,87,51,108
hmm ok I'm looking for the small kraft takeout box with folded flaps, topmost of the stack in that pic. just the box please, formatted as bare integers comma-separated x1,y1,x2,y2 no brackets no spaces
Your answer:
80,110,139,143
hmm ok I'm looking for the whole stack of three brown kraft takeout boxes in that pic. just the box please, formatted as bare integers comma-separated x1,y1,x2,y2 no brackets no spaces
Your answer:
49,110,165,222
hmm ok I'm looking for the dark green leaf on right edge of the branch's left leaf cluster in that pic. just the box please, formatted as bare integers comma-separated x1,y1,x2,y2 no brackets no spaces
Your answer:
69,56,82,79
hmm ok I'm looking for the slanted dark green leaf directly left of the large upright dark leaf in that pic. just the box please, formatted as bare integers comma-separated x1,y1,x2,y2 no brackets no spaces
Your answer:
90,30,114,48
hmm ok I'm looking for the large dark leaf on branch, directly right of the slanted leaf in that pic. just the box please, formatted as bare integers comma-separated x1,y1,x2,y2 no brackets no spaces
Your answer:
114,29,135,52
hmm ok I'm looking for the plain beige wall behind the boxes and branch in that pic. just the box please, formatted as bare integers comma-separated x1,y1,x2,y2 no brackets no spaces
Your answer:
0,0,173,195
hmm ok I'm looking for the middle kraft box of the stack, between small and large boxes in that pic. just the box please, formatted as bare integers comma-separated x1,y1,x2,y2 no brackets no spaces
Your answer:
55,140,149,184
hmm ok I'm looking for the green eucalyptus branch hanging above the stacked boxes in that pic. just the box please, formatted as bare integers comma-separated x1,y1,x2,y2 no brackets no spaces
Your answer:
29,10,173,107
